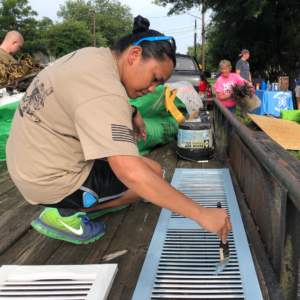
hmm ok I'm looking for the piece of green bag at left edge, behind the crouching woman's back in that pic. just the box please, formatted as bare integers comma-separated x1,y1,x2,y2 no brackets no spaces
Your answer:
0,101,20,161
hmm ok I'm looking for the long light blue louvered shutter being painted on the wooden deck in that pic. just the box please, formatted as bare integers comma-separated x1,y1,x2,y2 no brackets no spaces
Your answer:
132,169,262,300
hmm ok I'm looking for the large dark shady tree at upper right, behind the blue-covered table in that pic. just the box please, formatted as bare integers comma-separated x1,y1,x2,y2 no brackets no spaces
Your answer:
155,0,300,88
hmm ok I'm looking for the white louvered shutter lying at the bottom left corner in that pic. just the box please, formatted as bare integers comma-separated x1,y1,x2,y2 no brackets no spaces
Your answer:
0,264,117,300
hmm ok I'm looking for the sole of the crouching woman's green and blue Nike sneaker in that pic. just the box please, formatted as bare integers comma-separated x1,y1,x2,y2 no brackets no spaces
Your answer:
30,220,105,245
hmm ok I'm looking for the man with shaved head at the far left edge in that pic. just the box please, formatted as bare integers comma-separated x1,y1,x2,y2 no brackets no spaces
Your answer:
0,31,24,70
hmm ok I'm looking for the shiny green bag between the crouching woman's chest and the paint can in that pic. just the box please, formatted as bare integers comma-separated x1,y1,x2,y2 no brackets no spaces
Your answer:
129,85,186,155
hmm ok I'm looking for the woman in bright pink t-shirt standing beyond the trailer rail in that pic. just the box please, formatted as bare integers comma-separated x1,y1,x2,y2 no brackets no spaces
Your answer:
214,60,251,115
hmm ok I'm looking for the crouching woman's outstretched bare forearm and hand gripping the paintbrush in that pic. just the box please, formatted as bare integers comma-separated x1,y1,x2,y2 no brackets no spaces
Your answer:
107,155,231,243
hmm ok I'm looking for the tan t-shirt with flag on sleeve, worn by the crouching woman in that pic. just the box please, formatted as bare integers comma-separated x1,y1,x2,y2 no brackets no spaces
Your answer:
6,48,139,204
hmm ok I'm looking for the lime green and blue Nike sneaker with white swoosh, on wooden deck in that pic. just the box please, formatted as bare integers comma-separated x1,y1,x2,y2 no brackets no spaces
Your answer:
31,207,105,244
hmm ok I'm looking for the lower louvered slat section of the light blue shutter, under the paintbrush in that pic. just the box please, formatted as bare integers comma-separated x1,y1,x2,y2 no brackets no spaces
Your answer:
151,229,244,299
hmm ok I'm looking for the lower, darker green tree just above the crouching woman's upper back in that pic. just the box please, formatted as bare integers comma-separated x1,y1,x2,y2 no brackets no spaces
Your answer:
47,20,106,58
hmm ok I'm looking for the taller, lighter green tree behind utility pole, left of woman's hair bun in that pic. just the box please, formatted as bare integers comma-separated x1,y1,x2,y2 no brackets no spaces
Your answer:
57,0,133,47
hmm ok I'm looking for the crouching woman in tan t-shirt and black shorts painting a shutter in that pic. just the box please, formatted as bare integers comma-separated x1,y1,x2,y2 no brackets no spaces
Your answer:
7,16,231,244
